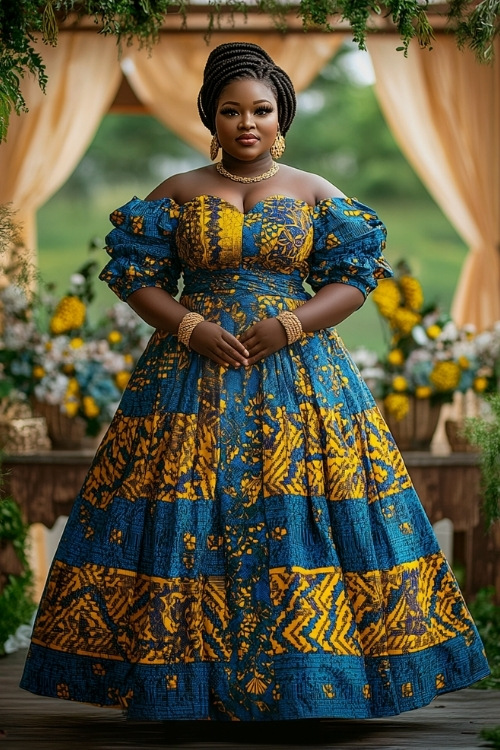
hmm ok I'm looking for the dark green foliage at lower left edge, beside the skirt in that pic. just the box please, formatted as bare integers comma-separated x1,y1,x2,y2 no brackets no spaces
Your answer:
0,490,35,656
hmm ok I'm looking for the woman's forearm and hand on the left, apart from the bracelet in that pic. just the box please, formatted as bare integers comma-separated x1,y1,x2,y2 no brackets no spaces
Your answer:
127,287,248,367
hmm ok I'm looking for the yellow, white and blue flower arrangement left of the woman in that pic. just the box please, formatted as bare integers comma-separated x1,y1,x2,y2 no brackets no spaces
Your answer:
0,248,150,436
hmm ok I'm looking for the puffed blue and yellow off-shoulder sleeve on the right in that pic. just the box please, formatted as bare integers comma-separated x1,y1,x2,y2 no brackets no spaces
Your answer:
307,198,393,297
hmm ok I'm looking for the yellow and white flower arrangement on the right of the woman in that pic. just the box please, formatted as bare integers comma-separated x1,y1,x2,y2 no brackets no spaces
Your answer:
365,262,500,420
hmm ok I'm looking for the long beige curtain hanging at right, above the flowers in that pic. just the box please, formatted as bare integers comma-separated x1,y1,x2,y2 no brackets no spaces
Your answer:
368,34,500,330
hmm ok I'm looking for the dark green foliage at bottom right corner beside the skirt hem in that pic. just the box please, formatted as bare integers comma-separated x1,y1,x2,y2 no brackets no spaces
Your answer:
469,586,500,690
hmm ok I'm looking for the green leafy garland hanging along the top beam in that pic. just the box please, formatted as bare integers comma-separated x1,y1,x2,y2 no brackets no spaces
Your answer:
0,0,500,141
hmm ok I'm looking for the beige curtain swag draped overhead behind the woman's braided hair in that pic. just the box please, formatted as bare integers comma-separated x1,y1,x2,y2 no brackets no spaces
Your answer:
122,32,344,158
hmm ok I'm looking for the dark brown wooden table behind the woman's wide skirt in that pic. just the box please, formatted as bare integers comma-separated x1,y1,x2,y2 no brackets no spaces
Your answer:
2,450,500,598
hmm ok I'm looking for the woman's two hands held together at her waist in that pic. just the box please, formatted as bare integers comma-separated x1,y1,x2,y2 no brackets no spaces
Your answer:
189,318,287,367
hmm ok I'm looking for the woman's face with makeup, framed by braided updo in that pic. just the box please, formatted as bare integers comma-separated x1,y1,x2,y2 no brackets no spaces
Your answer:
215,78,278,161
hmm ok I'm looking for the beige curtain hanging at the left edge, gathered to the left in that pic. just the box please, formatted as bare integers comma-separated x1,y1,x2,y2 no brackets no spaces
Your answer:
0,32,121,250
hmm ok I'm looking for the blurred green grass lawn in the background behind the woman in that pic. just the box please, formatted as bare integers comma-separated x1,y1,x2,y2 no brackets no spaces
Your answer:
38,185,467,351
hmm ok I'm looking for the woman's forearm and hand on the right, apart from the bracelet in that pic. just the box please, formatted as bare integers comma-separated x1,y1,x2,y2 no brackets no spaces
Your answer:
239,284,364,365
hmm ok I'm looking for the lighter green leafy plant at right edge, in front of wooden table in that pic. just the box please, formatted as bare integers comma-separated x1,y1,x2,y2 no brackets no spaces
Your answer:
464,393,500,532
